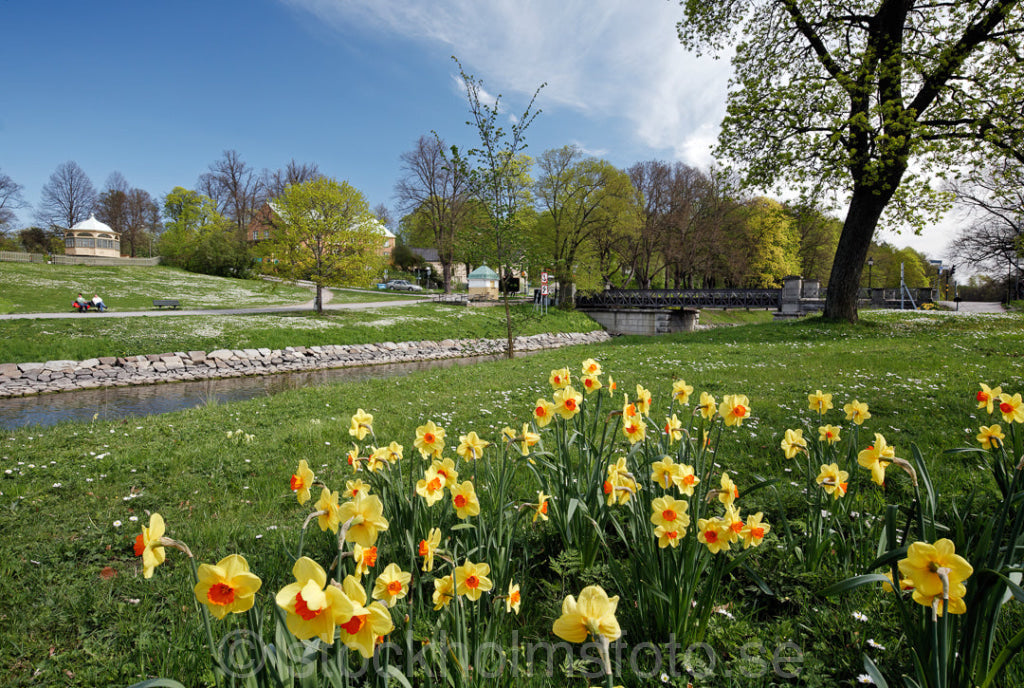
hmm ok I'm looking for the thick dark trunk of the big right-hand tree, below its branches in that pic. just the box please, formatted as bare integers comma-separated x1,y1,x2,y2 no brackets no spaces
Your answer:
824,187,891,323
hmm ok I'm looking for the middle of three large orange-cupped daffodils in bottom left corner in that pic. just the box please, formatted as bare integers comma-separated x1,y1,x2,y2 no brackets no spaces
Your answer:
275,557,344,645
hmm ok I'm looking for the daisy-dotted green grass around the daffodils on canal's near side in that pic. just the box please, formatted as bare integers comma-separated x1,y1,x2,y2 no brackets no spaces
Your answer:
0,313,1024,687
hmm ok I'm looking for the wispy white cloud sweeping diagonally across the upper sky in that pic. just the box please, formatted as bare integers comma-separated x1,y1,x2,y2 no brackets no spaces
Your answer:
282,0,730,165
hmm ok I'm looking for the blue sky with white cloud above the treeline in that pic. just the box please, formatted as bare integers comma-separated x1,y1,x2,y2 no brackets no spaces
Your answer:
0,0,950,258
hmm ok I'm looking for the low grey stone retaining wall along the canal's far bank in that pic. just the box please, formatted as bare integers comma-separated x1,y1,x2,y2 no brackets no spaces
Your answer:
0,331,609,398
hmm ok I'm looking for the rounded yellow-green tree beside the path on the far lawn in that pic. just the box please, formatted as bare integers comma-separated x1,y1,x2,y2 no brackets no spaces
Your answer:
270,177,384,313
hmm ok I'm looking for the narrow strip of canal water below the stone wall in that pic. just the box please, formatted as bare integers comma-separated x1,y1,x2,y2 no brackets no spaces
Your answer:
0,354,512,430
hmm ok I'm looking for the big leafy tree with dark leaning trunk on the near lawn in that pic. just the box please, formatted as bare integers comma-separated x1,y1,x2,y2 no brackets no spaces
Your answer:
678,0,1024,321
